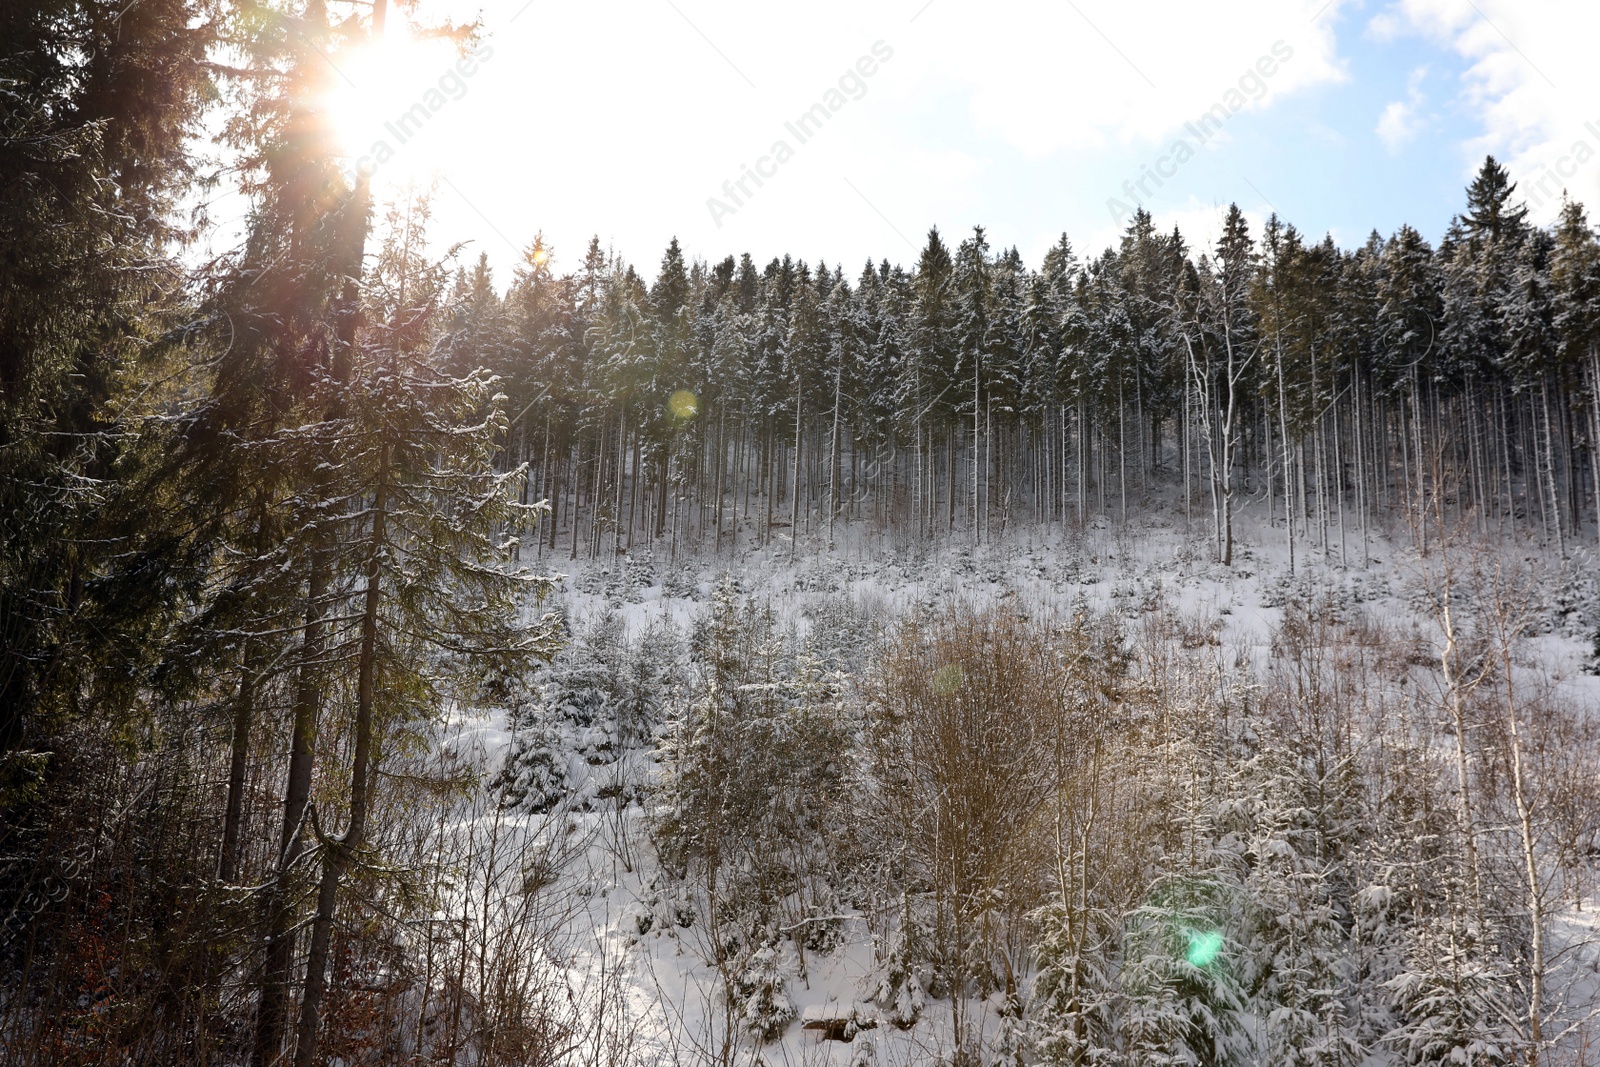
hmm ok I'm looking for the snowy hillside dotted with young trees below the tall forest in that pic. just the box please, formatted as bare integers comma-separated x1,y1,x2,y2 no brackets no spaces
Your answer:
438,507,1600,1064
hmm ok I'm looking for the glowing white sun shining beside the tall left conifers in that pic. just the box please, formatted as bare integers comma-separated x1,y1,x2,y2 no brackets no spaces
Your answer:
326,27,475,182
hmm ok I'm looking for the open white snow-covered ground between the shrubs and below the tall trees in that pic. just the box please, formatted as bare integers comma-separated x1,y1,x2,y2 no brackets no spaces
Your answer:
458,509,1600,1065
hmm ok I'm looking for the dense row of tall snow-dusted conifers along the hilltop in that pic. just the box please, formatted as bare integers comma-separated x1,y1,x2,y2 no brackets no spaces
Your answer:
473,158,1600,561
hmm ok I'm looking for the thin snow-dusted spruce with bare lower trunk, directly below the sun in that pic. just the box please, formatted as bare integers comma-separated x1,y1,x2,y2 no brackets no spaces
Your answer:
290,202,552,1067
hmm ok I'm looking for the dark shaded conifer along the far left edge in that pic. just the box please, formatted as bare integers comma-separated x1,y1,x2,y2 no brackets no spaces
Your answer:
0,0,222,764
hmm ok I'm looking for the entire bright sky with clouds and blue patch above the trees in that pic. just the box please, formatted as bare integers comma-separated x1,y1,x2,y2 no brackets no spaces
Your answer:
294,0,1600,283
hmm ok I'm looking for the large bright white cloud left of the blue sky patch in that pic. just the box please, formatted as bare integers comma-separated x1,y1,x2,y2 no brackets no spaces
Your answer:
384,0,1347,279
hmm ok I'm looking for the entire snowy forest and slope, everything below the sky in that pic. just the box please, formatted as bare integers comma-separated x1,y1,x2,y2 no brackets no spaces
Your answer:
9,0,1600,1067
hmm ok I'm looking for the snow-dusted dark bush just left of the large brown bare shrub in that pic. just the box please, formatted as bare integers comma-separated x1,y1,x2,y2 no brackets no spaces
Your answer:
654,582,856,1033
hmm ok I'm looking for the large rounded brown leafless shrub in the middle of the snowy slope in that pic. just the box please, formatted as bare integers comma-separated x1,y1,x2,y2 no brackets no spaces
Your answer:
866,605,1070,1046
